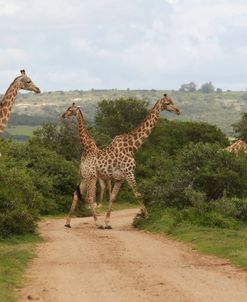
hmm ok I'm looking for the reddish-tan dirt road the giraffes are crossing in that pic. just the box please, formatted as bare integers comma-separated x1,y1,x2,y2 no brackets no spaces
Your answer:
20,209,247,302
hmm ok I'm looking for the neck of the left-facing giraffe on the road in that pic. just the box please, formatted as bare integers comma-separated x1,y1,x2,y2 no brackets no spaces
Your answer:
76,109,99,156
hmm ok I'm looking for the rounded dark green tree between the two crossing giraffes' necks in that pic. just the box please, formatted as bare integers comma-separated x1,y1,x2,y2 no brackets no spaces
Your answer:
95,98,148,138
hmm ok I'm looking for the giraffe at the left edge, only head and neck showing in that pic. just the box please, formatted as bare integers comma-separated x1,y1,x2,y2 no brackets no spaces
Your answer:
0,69,40,156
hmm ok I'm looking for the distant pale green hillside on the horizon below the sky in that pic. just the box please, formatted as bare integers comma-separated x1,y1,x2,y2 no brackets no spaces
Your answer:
1,89,247,136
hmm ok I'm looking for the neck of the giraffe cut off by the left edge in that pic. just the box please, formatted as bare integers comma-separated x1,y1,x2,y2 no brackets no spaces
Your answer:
0,81,19,135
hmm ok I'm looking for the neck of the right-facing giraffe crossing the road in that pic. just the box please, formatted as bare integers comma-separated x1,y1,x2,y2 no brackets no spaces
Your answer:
128,101,162,151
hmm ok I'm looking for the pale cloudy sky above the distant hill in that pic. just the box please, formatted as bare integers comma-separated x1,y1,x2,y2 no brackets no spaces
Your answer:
0,0,247,93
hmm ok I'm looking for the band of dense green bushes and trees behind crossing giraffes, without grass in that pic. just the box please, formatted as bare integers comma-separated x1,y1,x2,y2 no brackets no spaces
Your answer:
0,98,247,237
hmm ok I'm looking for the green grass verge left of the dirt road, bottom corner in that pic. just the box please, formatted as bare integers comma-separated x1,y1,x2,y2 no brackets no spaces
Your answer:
0,235,41,302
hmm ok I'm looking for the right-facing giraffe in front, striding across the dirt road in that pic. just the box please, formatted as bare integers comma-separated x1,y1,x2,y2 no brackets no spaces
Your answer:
62,94,180,229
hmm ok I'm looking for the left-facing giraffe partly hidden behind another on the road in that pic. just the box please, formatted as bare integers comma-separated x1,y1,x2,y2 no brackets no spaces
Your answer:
62,103,111,227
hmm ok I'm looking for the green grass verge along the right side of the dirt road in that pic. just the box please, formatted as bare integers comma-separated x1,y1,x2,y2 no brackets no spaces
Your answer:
134,209,247,269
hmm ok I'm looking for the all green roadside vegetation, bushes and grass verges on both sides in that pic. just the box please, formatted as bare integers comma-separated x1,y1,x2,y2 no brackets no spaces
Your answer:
0,98,247,301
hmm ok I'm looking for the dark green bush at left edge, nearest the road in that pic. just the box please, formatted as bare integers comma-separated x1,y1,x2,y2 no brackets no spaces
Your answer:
0,159,42,237
